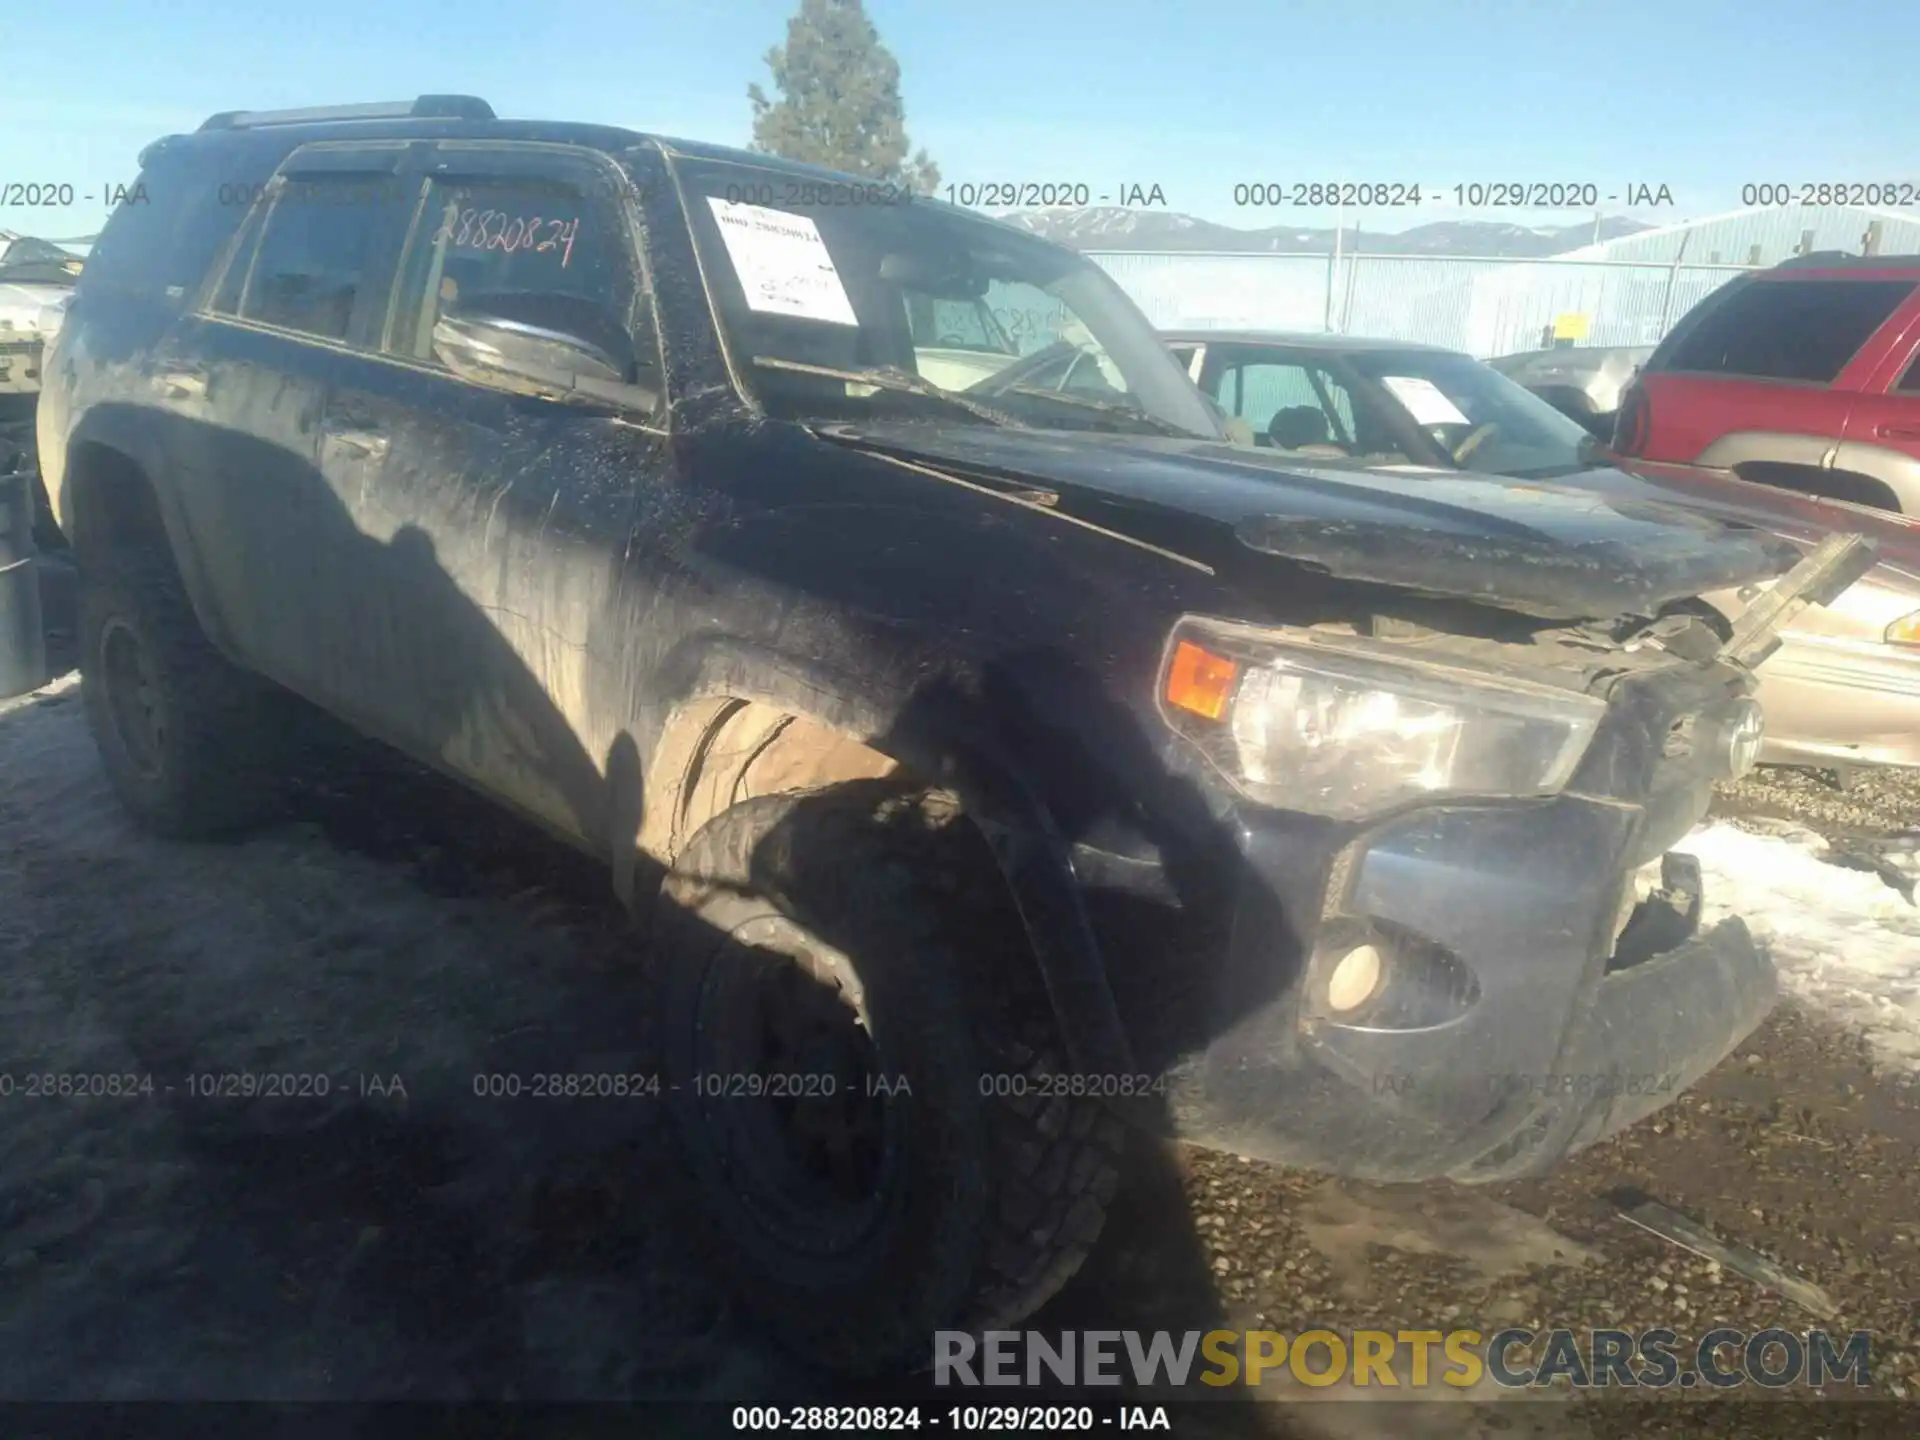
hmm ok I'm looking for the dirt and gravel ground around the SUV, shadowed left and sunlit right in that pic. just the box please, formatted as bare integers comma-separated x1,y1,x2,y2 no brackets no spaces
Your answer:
0,556,1920,1436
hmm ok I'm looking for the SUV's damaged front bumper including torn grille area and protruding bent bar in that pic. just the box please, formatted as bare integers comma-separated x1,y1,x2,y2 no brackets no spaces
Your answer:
1081,536,1872,1183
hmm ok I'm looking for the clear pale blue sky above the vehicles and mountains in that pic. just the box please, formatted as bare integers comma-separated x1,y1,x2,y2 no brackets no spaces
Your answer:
0,0,1920,236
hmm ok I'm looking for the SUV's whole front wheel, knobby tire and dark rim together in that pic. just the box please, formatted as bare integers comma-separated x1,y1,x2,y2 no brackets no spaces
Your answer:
660,781,1123,1373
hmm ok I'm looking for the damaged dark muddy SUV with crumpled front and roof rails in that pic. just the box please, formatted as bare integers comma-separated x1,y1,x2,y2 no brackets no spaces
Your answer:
38,96,1864,1369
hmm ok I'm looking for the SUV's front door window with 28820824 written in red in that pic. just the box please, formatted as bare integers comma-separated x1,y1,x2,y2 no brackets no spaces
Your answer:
384,175,660,401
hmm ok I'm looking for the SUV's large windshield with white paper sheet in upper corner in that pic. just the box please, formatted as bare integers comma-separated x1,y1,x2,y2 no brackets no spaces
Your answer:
676,159,1223,440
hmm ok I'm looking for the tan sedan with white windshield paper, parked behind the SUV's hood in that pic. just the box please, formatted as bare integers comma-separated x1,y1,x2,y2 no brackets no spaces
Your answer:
1165,330,1920,770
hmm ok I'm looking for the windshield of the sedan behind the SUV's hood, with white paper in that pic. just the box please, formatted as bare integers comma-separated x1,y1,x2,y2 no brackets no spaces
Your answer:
1352,349,1599,478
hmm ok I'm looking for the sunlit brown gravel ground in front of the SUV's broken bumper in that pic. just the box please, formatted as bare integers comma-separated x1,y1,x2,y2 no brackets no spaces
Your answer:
1075,768,1920,1440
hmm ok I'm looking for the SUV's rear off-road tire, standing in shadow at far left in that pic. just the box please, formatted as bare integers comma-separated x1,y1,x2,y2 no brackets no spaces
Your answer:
79,545,284,839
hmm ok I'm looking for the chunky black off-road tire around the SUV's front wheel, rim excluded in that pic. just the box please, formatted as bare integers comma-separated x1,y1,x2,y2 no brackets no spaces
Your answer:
657,781,1125,1373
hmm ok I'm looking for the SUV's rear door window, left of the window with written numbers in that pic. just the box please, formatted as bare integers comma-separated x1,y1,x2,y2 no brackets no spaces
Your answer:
234,175,399,340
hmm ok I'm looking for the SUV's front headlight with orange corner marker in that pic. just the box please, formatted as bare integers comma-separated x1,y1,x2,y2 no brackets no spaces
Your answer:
1160,620,1607,820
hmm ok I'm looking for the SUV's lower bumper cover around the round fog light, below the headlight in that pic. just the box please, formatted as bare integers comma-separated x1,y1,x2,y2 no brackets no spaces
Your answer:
1144,797,1778,1183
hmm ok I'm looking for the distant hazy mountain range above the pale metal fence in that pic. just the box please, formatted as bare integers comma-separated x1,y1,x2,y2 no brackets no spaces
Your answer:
998,205,1653,259
